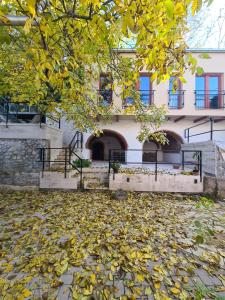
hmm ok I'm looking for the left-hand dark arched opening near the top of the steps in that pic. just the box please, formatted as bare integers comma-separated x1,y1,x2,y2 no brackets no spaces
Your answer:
86,129,127,162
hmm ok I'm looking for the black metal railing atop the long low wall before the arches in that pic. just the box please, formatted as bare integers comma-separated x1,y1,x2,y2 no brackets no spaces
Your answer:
108,149,202,181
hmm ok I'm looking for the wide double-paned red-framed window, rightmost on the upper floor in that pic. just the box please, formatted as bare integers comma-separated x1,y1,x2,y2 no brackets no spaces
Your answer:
195,74,223,109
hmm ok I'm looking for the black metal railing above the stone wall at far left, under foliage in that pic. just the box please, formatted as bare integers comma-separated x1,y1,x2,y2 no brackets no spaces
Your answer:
0,97,61,129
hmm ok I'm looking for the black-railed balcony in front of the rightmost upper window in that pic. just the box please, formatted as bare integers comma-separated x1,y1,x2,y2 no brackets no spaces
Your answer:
195,90,225,109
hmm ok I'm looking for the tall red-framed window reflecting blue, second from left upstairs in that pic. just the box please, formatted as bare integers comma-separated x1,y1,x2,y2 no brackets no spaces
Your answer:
124,73,154,106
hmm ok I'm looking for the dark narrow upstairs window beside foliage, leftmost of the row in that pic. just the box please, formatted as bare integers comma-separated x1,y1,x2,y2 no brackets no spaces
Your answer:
99,74,112,106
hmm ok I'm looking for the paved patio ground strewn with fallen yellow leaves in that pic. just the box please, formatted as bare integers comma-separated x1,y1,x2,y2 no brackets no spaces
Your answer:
0,192,225,300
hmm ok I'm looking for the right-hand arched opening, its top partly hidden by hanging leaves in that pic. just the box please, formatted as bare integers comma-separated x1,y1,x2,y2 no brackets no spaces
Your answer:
143,131,183,164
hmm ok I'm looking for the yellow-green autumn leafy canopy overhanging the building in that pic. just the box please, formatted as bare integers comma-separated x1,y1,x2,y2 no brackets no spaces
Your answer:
0,0,211,134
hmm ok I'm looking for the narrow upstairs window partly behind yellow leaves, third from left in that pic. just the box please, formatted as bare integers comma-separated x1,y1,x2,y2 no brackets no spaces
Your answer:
169,76,184,109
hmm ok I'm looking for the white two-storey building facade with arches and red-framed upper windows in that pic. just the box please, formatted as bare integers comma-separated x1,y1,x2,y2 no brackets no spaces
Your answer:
62,49,225,163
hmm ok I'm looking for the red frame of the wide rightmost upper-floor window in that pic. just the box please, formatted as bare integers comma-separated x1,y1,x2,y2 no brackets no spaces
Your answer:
195,73,224,108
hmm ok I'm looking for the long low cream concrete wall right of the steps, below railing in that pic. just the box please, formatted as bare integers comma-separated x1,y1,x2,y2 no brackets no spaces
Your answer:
109,173,203,193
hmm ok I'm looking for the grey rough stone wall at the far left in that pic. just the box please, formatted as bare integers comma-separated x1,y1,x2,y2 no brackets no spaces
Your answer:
0,138,49,187
